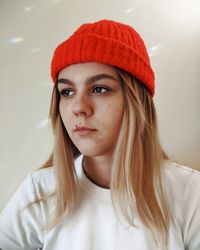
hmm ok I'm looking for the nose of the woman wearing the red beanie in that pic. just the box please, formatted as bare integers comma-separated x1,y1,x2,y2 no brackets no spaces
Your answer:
72,95,93,116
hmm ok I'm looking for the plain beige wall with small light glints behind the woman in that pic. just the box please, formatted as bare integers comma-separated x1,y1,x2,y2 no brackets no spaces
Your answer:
0,0,200,208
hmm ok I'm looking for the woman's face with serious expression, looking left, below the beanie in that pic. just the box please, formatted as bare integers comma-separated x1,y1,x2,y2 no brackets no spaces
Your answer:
58,62,123,156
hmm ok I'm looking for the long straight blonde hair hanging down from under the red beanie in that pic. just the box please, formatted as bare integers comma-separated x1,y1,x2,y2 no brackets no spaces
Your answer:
26,67,170,249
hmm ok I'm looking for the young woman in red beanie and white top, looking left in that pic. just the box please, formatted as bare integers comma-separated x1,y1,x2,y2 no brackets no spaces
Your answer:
0,20,200,250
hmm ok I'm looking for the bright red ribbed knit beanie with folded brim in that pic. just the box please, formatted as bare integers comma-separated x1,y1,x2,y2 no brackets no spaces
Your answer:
51,20,155,96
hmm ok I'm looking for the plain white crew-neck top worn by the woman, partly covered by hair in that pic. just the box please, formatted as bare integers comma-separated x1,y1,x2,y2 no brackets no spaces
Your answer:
0,155,200,250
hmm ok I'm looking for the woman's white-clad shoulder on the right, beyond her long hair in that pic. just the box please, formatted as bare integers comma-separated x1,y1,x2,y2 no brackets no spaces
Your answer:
163,161,200,246
